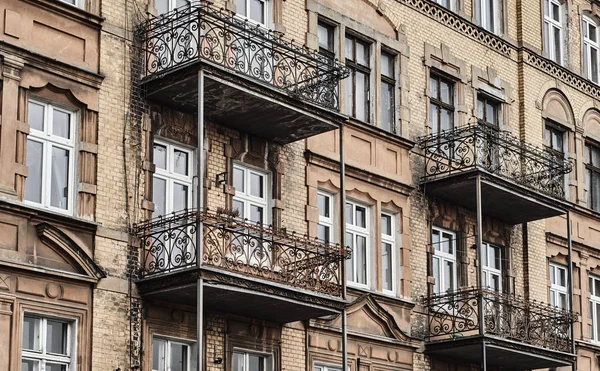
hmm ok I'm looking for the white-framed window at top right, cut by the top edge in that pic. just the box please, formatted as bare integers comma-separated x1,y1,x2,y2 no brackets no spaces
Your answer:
544,0,565,64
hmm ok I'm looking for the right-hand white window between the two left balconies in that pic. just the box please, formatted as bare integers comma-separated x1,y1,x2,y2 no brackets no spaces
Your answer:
233,164,271,224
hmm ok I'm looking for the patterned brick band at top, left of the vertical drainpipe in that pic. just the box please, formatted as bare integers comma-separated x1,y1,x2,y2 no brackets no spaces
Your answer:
397,0,514,56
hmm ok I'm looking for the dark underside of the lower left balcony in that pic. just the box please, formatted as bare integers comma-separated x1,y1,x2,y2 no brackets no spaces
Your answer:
138,268,344,323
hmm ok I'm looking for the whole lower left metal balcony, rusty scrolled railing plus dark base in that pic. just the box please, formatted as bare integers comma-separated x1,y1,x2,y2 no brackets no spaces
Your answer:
134,210,349,322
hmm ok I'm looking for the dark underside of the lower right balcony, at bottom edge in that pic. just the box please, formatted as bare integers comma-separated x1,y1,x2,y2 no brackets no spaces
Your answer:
426,336,574,370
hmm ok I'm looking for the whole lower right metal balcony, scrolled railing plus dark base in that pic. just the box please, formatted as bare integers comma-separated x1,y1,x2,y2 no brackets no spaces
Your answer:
423,288,577,370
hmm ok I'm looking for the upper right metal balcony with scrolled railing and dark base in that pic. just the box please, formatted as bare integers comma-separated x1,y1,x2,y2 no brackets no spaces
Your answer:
418,125,572,224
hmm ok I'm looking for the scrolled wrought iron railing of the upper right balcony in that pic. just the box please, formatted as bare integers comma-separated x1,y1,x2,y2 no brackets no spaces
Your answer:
419,125,572,199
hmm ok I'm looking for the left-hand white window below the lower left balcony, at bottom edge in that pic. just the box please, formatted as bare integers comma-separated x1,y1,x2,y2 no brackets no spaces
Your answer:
152,337,191,371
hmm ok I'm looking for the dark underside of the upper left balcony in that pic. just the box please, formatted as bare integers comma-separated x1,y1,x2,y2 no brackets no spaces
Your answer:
145,62,343,144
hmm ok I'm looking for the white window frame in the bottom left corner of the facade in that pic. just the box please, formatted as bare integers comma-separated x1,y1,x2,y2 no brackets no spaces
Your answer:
21,312,77,371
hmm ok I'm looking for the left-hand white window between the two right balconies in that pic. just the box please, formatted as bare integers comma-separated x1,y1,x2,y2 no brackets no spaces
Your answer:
431,227,458,294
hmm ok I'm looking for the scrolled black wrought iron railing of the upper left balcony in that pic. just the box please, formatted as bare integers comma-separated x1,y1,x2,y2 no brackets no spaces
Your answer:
138,3,348,111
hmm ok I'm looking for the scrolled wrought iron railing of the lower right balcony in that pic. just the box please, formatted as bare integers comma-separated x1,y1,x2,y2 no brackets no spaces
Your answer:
423,288,577,353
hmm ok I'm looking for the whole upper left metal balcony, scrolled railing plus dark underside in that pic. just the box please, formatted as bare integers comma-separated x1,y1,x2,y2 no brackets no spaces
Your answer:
138,3,348,143
